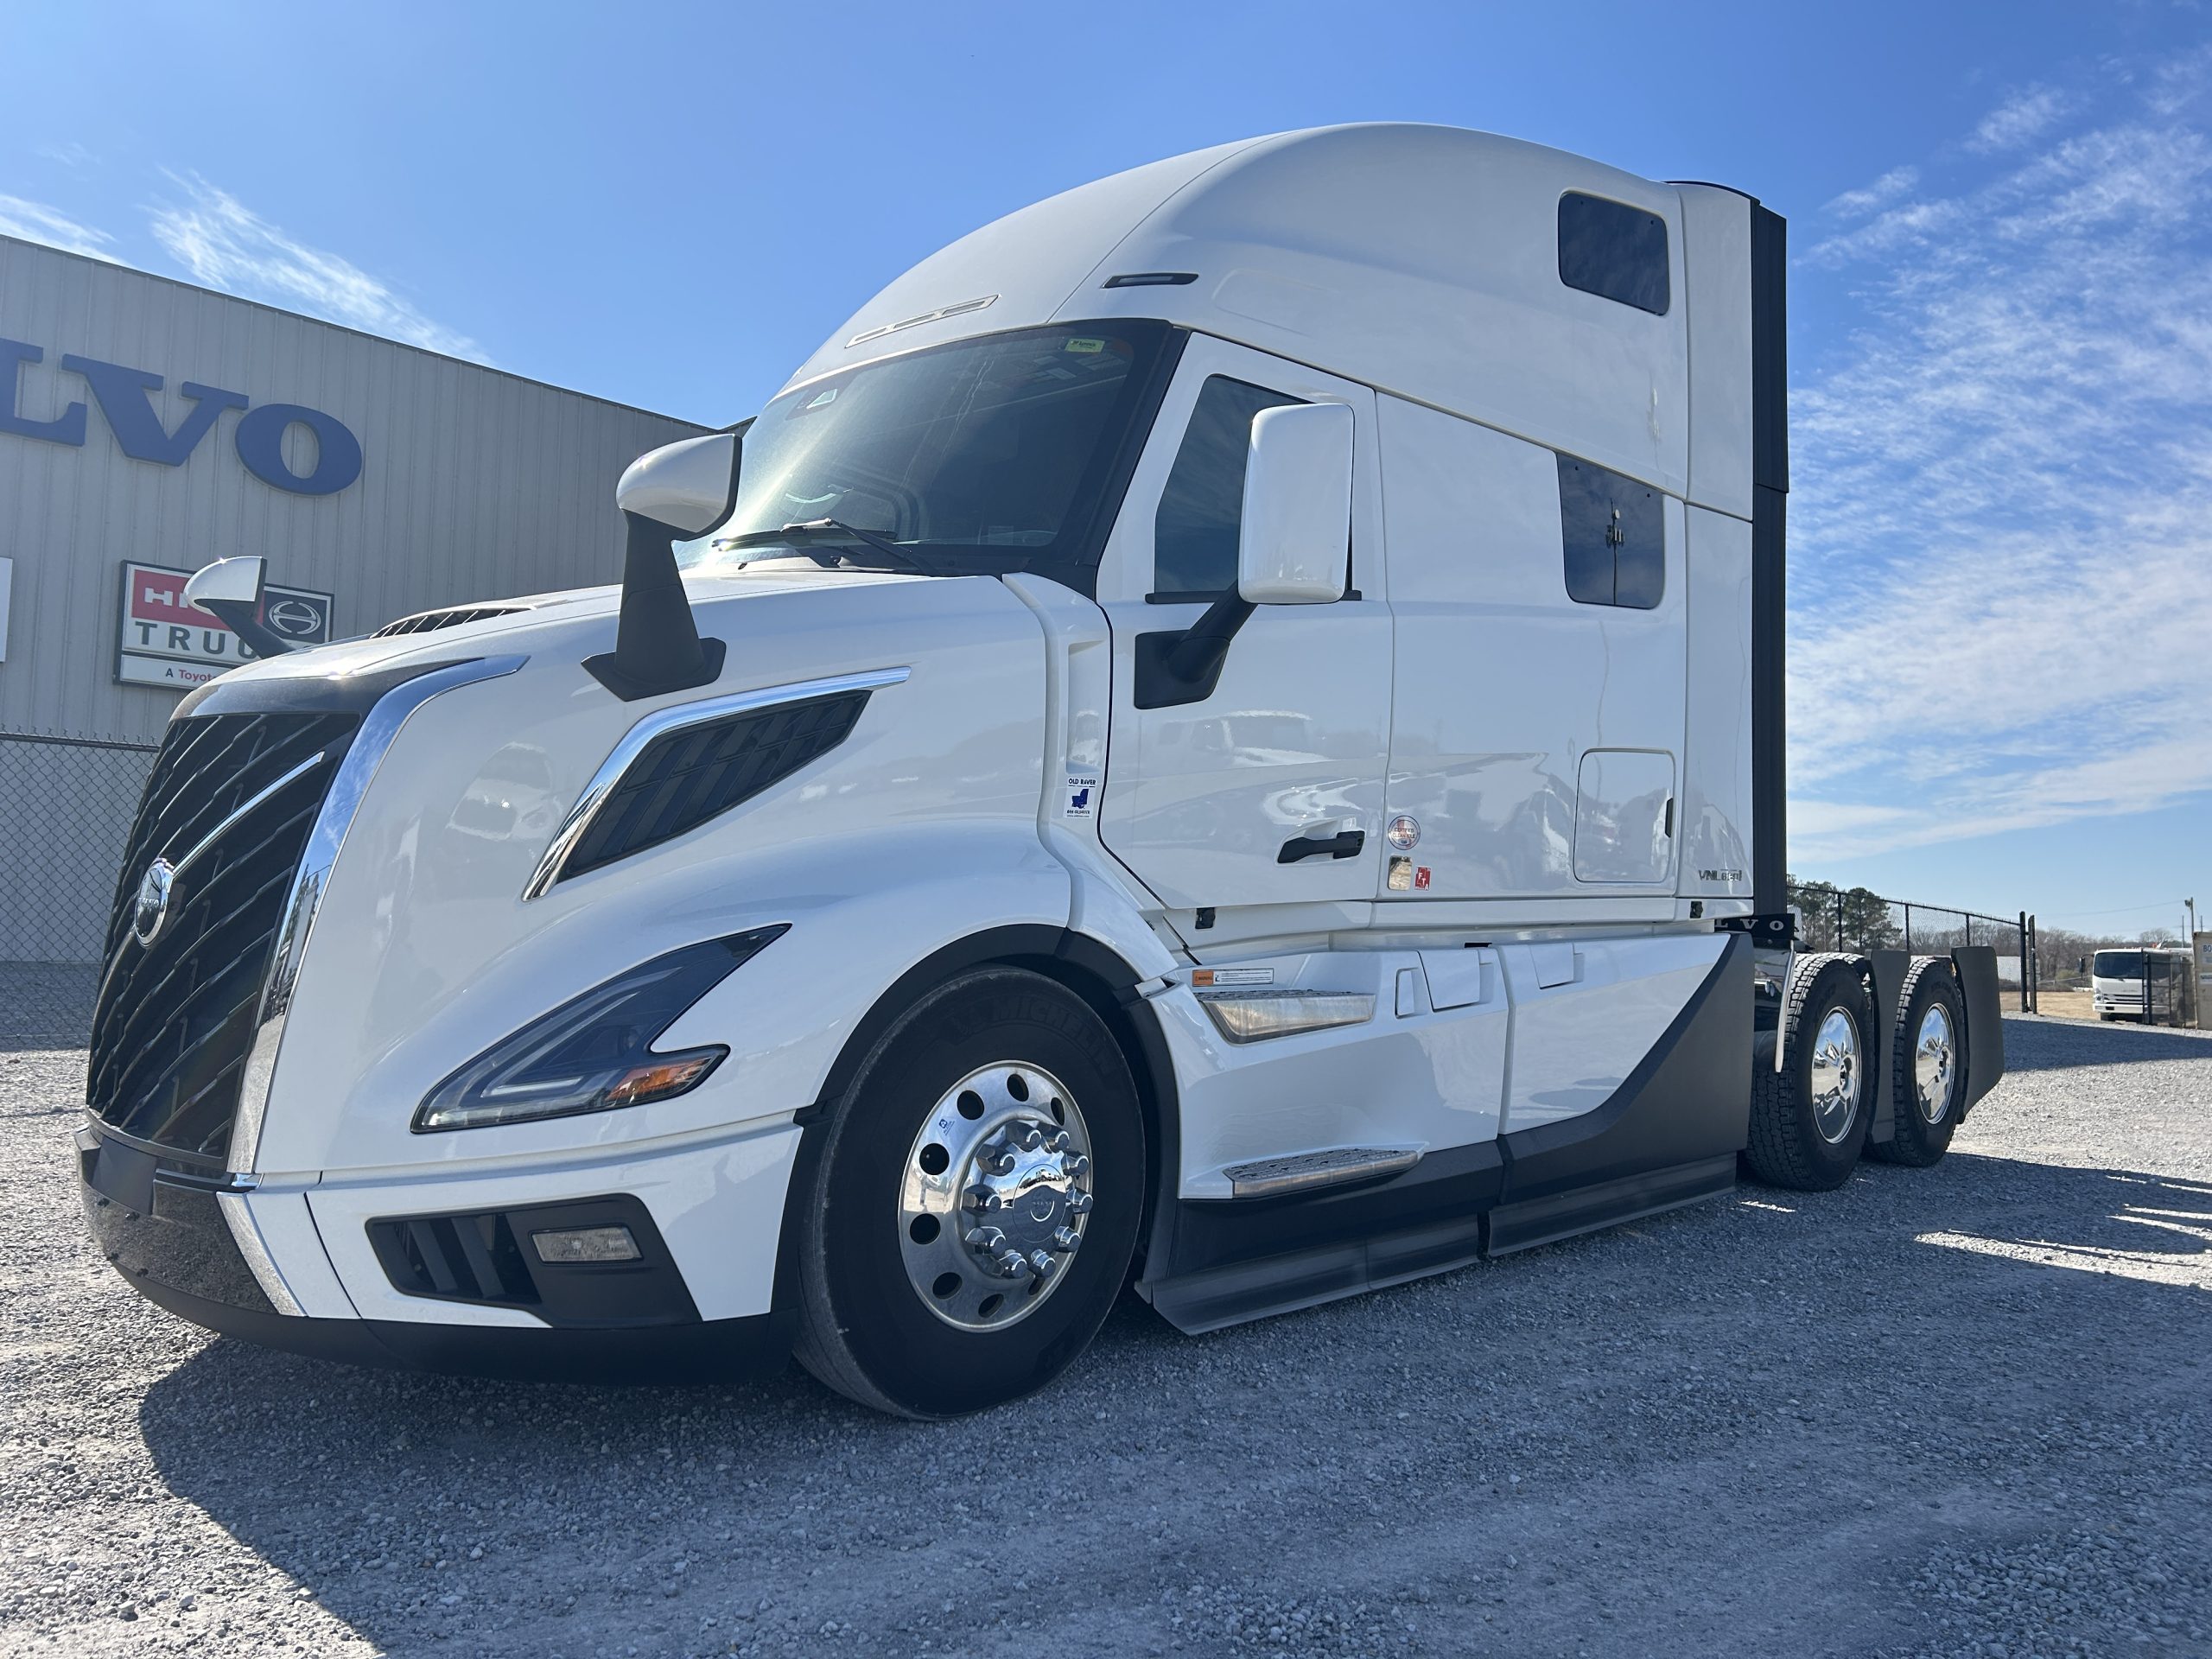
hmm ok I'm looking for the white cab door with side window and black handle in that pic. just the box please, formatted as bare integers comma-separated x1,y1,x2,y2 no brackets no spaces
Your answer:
1097,334,1391,931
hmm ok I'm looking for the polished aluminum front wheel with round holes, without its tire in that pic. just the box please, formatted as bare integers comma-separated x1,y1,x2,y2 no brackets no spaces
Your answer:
898,1062,1093,1332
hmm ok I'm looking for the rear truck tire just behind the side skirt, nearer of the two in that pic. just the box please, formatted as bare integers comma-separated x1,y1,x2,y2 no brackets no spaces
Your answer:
1743,953,1873,1192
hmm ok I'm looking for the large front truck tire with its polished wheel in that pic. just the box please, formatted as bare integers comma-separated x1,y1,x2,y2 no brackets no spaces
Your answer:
791,967,1146,1418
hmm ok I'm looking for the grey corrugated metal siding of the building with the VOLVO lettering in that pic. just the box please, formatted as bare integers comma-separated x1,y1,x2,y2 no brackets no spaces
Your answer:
0,237,702,743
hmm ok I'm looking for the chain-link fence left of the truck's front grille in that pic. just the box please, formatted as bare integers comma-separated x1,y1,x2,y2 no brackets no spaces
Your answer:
0,732,155,963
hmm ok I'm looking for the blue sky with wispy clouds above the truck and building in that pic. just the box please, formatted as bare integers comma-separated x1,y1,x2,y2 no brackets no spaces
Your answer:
0,0,2212,933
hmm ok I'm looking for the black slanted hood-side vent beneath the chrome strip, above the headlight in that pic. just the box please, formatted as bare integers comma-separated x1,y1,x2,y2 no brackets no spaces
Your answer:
562,692,868,878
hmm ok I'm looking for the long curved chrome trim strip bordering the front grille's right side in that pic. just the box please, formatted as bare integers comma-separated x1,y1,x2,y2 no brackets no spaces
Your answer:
226,657,529,1185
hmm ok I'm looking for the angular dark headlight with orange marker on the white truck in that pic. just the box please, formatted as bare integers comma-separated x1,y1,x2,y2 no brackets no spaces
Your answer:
414,923,790,1135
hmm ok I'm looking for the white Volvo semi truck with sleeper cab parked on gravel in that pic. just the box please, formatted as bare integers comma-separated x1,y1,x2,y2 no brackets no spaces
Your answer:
78,124,2004,1418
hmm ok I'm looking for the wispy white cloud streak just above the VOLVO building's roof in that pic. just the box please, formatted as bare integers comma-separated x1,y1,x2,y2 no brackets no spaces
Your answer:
149,173,491,363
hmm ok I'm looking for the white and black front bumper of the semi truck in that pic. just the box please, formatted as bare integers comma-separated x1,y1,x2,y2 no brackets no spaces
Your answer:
78,1119,798,1382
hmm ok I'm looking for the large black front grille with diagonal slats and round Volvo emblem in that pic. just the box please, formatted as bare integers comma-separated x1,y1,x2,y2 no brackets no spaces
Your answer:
86,712,359,1166
